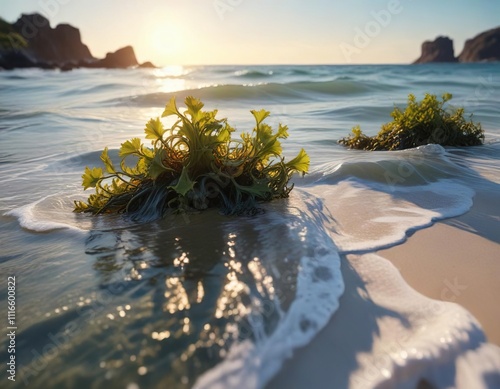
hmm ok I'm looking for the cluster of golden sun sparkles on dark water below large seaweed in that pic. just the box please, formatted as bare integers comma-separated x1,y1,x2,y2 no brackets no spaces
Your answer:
145,227,286,374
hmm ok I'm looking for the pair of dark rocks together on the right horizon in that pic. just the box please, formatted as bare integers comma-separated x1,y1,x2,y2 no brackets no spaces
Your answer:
414,27,500,63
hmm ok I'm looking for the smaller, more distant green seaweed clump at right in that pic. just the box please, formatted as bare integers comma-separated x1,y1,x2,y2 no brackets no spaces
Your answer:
338,93,484,150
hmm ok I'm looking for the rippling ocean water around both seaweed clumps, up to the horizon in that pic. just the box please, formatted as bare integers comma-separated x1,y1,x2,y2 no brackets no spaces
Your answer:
0,64,500,389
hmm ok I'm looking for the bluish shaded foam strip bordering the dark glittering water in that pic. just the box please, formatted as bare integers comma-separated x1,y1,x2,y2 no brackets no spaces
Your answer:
193,232,344,389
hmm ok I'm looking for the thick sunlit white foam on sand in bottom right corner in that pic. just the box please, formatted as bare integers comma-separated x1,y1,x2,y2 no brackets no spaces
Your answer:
350,254,500,389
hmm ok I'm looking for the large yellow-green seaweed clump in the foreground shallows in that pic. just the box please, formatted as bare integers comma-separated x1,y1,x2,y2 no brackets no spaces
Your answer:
75,97,309,219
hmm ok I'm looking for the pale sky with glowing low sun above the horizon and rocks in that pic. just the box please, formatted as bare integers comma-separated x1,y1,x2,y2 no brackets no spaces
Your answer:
0,0,500,66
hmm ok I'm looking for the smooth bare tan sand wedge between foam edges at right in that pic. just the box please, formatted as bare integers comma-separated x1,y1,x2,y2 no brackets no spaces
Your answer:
379,192,500,345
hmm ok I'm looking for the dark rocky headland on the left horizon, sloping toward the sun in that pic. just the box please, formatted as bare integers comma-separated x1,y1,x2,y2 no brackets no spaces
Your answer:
0,13,155,70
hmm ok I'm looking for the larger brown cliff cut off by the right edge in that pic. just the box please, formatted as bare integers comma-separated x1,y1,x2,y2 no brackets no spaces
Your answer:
458,27,500,62
